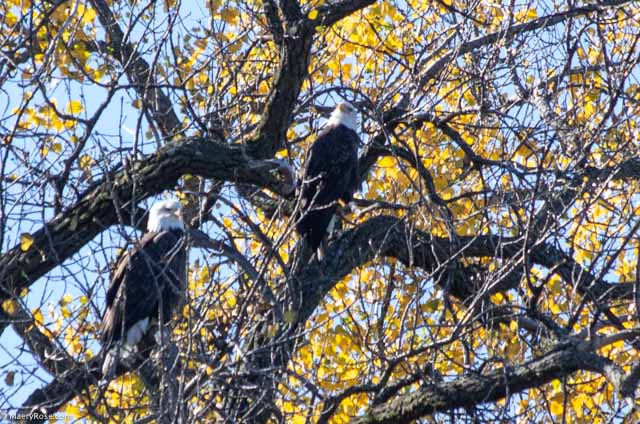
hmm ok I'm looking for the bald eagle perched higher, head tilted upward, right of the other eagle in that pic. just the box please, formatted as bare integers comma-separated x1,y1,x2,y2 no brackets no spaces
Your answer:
296,102,360,259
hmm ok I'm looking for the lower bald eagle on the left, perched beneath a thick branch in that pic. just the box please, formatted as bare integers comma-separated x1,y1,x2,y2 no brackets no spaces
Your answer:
101,200,187,381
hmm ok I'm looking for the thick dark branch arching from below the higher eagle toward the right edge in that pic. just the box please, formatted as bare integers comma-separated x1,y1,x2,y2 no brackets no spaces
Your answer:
300,216,633,321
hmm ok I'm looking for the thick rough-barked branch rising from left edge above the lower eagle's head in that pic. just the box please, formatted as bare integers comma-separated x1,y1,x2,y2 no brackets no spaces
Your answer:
0,138,289,332
